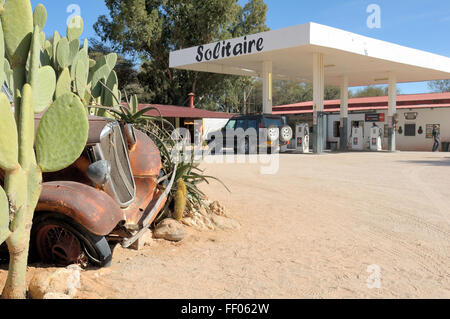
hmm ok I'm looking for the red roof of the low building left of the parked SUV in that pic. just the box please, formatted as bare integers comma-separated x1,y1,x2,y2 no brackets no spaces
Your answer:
139,104,233,119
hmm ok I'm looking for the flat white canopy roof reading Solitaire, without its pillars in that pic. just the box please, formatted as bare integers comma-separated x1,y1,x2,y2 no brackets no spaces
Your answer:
170,23,450,86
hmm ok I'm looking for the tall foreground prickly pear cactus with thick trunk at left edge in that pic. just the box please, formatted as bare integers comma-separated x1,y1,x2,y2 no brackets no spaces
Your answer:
0,0,89,298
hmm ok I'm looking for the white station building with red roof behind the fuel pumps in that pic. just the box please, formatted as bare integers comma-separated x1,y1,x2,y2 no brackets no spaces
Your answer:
272,92,450,151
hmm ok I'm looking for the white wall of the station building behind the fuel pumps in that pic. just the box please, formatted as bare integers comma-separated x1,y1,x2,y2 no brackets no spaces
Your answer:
327,108,450,151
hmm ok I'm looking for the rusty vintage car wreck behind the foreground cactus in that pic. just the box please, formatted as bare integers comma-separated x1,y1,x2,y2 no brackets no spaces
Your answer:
0,116,174,267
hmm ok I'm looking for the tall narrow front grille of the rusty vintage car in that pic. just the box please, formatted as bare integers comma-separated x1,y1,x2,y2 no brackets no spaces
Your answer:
95,122,136,208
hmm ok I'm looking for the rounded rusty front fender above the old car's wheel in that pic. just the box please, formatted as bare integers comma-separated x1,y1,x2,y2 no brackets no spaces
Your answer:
35,181,125,236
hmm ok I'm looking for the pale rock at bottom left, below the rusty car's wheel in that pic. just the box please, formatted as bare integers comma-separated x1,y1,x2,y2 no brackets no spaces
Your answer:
28,265,81,299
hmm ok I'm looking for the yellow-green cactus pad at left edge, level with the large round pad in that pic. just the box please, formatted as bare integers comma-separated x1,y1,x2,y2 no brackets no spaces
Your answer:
0,93,19,171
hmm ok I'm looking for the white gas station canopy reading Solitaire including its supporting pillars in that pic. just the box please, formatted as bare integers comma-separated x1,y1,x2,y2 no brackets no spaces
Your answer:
170,22,450,153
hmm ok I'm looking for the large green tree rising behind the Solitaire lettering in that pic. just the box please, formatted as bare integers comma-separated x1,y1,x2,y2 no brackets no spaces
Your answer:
94,0,268,109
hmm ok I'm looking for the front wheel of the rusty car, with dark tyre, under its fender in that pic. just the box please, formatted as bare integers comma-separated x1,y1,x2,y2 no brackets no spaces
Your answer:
31,214,112,268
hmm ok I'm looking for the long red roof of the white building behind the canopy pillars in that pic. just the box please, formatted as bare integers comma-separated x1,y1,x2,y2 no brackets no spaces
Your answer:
273,92,450,114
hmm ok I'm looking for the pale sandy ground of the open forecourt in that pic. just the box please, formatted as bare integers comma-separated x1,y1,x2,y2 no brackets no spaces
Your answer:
0,153,450,299
